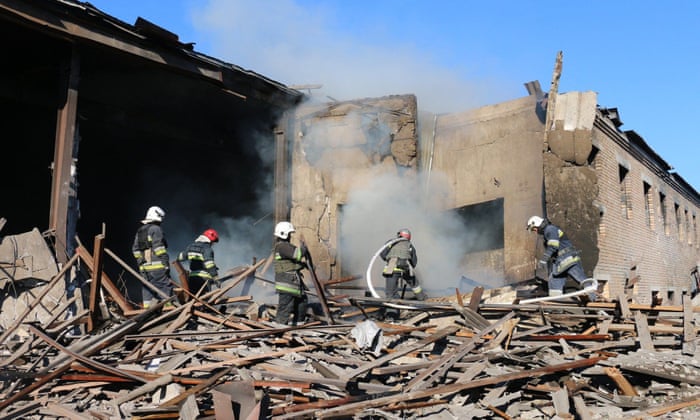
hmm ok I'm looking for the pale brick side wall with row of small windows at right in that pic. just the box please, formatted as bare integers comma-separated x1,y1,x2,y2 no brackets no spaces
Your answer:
592,116,700,304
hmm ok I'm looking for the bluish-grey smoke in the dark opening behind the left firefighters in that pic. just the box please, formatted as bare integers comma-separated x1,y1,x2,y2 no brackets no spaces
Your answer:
163,129,276,303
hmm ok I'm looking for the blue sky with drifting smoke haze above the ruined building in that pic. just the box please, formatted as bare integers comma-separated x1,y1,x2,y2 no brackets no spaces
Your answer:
90,0,700,190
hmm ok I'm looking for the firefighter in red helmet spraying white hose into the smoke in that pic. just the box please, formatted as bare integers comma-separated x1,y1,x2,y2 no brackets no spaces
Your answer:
379,229,426,306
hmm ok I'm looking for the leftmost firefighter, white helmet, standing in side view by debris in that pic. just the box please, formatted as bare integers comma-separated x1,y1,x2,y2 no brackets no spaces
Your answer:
131,206,173,308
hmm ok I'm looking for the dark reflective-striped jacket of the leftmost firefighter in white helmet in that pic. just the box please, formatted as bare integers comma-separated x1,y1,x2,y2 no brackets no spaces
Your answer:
131,223,170,272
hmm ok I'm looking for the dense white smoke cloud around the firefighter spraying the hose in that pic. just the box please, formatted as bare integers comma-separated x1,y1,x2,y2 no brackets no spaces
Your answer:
341,174,473,295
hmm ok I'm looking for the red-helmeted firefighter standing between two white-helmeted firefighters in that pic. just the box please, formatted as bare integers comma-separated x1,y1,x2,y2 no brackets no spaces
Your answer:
177,229,219,296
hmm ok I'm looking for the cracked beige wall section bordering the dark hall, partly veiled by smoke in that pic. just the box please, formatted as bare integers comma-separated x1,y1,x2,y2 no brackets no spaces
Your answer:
291,95,418,278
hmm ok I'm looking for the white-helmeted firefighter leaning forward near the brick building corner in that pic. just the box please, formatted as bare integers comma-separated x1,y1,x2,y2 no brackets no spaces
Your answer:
527,216,595,300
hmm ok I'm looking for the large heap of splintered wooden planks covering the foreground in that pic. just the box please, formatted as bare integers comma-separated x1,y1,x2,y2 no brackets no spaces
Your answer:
0,230,700,419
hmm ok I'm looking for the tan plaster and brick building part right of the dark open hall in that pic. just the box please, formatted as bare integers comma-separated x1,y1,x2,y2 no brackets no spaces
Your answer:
291,78,700,304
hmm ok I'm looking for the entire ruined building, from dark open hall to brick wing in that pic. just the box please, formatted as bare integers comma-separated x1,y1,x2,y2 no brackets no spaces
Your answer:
0,1,700,308
